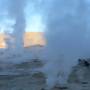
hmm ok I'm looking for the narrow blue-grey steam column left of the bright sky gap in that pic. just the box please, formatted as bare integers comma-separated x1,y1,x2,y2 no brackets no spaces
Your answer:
8,0,27,48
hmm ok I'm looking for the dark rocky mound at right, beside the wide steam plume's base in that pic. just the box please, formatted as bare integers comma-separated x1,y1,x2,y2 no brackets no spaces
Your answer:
68,59,90,83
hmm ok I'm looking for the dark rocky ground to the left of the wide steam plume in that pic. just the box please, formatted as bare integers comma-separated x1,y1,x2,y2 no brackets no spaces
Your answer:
0,60,45,90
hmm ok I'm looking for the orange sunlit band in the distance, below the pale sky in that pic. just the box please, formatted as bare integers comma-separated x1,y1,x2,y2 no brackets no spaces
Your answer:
0,32,46,48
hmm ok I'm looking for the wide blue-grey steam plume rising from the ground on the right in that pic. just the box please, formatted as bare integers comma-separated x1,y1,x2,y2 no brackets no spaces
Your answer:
44,0,90,88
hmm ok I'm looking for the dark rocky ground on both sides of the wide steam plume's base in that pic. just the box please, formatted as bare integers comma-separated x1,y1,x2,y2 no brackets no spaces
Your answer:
0,60,90,90
